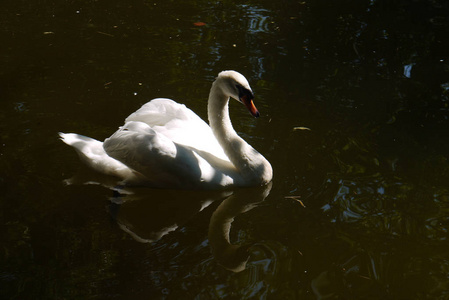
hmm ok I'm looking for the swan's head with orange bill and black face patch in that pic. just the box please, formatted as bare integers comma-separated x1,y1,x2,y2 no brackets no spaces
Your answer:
215,71,260,118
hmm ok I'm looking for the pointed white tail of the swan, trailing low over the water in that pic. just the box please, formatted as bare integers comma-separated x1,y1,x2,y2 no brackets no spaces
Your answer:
59,132,139,181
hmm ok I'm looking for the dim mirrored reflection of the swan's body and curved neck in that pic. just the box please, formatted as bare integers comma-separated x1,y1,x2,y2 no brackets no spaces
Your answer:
110,183,272,272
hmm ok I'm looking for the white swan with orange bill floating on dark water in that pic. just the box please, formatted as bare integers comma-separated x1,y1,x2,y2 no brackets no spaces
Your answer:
60,71,273,189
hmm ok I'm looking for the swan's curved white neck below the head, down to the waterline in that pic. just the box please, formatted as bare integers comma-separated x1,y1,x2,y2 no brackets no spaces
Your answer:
208,82,273,185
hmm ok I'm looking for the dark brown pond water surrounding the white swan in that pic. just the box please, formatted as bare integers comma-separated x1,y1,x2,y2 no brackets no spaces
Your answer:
0,0,449,299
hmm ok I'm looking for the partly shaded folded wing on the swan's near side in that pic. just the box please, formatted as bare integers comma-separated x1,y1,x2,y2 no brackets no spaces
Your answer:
103,121,201,188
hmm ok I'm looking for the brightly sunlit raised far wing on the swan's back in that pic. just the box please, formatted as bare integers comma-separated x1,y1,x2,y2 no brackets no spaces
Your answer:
125,98,229,161
